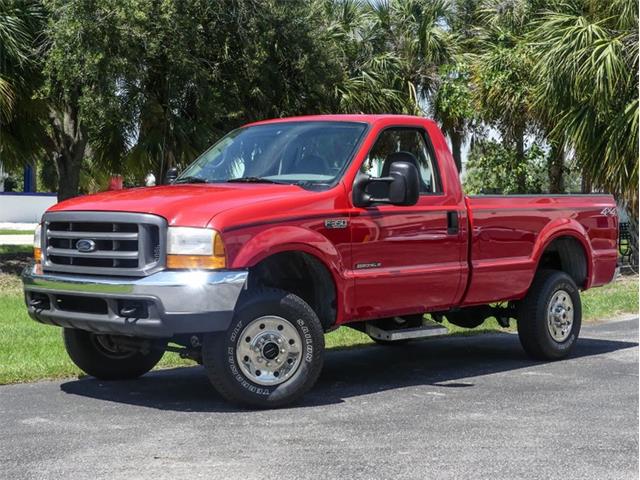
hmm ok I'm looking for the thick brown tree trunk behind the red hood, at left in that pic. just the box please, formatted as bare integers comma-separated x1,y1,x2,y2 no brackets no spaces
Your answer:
49,104,87,201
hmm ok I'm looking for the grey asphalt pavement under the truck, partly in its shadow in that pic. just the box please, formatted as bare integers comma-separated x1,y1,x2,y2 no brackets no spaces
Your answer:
0,319,638,480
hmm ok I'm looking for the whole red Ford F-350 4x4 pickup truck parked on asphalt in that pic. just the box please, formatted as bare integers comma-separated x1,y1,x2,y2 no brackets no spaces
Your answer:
23,115,618,407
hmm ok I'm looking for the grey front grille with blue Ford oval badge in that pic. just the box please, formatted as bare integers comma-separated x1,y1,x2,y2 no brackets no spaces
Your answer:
42,212,166,276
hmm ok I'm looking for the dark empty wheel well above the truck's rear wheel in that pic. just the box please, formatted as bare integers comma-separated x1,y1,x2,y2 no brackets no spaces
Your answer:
538,236,587,287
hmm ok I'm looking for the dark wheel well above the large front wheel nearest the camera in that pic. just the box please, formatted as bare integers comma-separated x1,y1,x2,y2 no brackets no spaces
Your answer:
248,251,337,330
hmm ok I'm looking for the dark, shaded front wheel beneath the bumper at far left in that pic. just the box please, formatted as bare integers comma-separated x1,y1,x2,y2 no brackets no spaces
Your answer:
62,328,167,380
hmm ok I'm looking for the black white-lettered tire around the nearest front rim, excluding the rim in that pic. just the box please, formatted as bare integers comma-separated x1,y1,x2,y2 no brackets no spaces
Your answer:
202,288,324,408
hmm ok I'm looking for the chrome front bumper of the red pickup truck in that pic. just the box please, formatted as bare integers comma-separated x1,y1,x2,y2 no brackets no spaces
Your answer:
22,265,248,338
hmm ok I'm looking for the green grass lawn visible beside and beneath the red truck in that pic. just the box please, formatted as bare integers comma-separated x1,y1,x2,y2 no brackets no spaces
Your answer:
0,274,638,384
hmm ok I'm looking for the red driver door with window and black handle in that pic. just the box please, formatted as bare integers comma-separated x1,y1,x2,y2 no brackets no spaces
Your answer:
351,127,465,319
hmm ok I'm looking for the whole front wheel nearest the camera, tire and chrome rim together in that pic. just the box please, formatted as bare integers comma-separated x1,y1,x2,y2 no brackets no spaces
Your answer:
202,289,324,408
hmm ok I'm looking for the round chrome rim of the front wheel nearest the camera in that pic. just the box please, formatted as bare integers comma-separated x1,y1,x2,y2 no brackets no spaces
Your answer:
236,315,302,386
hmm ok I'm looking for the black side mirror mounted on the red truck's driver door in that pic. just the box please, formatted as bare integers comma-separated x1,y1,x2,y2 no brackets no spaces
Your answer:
353,162,420,207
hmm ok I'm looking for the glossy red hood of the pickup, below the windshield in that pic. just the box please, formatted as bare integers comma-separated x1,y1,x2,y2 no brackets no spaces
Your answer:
49,183,309,227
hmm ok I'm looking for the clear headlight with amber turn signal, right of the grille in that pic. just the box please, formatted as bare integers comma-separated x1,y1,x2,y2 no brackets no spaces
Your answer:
167,227,226,269
